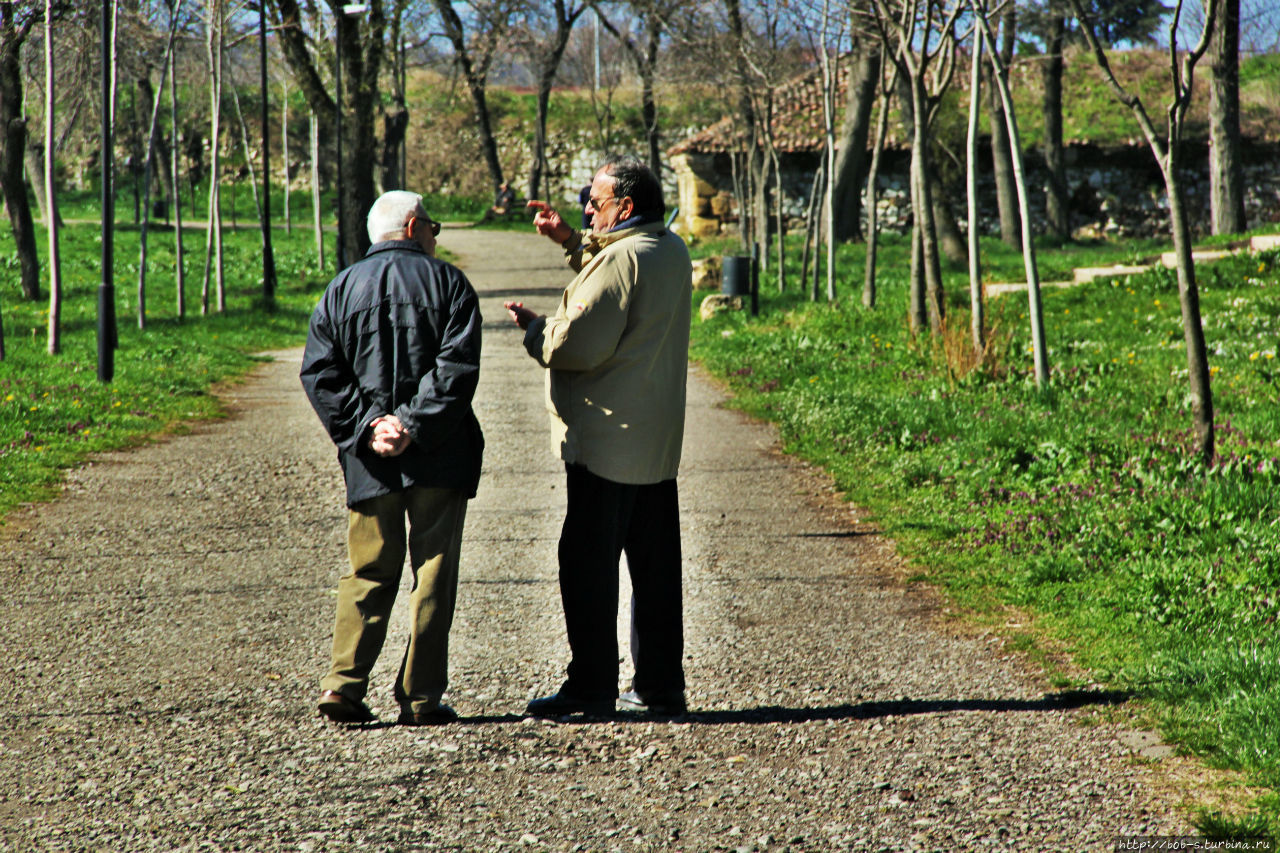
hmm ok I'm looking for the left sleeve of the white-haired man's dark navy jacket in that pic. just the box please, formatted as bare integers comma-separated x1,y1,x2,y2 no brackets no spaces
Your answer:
301,292,384,453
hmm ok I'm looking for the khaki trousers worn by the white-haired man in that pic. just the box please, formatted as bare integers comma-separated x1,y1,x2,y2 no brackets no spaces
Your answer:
320,487,467,712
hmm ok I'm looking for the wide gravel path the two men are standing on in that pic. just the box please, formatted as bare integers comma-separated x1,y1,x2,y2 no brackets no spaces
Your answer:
0,231,1185,852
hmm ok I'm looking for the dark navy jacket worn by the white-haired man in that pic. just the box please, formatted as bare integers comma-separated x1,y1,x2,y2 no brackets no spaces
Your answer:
302,240,484,506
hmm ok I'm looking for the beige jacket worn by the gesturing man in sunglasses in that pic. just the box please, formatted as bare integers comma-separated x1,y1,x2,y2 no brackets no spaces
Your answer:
525,222,692,484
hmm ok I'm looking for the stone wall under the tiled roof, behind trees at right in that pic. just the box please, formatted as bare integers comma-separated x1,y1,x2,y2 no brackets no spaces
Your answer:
672,143,1280,237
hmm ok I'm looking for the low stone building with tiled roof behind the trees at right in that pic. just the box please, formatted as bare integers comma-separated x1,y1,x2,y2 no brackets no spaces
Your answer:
668,56,1280,238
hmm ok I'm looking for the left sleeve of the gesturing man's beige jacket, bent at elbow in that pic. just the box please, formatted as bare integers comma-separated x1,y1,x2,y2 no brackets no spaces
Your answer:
525,244,635,370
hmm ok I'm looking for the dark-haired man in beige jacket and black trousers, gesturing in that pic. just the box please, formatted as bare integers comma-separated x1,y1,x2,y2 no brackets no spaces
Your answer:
504,158,692,716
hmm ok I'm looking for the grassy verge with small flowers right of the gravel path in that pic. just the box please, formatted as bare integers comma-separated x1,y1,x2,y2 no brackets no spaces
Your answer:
692,229,1280,835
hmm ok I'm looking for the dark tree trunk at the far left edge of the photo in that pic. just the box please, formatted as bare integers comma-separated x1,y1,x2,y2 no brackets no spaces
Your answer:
0,9,40,301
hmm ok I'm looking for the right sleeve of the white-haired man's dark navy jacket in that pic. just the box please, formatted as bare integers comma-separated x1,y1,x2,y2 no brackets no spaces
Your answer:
393,272,481,450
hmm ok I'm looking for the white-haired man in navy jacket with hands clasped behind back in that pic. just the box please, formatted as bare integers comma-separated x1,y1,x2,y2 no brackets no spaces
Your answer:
302,190,484,725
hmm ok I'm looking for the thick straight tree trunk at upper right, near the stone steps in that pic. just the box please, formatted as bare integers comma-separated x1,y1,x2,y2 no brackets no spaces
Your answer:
1208,0,1248,234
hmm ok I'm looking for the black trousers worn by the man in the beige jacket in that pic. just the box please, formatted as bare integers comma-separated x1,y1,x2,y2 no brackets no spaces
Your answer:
559,465,685,698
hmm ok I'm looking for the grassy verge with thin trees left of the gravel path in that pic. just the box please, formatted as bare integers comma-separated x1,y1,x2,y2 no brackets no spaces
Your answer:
0,225,332,519
